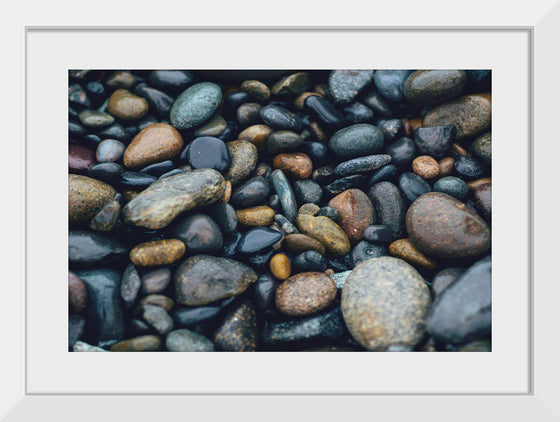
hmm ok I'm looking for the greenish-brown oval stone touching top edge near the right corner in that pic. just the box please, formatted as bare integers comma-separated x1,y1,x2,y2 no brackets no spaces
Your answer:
403,69,467,105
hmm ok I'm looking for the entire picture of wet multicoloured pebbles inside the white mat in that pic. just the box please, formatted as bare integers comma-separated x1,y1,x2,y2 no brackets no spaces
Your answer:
68,70,492,352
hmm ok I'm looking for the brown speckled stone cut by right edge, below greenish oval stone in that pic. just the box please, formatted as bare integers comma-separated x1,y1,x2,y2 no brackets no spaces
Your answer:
423,95,492,140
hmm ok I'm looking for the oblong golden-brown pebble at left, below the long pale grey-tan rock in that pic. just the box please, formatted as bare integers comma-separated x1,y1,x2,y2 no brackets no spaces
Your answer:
130,239,185,267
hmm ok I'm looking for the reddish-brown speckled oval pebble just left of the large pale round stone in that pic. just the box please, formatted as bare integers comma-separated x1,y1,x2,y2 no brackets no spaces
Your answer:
275,272,336,316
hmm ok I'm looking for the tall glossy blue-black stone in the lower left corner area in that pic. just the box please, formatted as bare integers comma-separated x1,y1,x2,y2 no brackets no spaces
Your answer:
76,269,124,344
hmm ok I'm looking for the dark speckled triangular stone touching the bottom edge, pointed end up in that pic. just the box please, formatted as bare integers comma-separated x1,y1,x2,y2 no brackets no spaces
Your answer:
212,300,258,352
